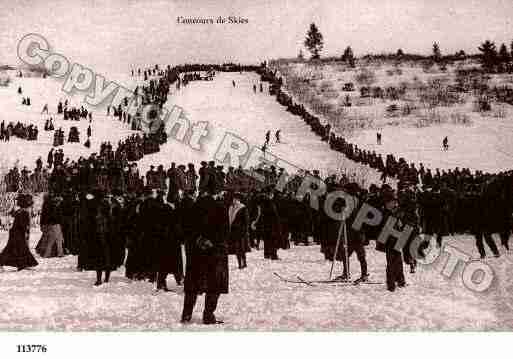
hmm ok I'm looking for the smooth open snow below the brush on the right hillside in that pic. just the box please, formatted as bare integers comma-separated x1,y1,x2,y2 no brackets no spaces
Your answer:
351,116,513,173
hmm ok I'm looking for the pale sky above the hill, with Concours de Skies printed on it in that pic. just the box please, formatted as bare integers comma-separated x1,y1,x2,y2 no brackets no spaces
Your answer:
0,0,513,72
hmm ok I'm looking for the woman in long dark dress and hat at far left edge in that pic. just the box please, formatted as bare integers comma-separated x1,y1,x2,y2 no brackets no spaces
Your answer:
0,195,38,271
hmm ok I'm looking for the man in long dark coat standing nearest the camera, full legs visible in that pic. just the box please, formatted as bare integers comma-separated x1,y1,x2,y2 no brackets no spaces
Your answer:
181,191,228,324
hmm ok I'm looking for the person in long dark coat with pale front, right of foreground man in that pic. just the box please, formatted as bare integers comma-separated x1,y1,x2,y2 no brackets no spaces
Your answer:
228,193,250,269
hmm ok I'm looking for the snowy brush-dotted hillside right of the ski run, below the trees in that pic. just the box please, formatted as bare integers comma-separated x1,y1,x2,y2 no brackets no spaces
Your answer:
281,63,513,173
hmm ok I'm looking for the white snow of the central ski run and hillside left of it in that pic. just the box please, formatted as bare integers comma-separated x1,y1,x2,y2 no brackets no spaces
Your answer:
0,73,379,187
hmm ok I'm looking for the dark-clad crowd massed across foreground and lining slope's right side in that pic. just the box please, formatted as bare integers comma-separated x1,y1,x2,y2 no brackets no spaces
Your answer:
0,63,513,324
